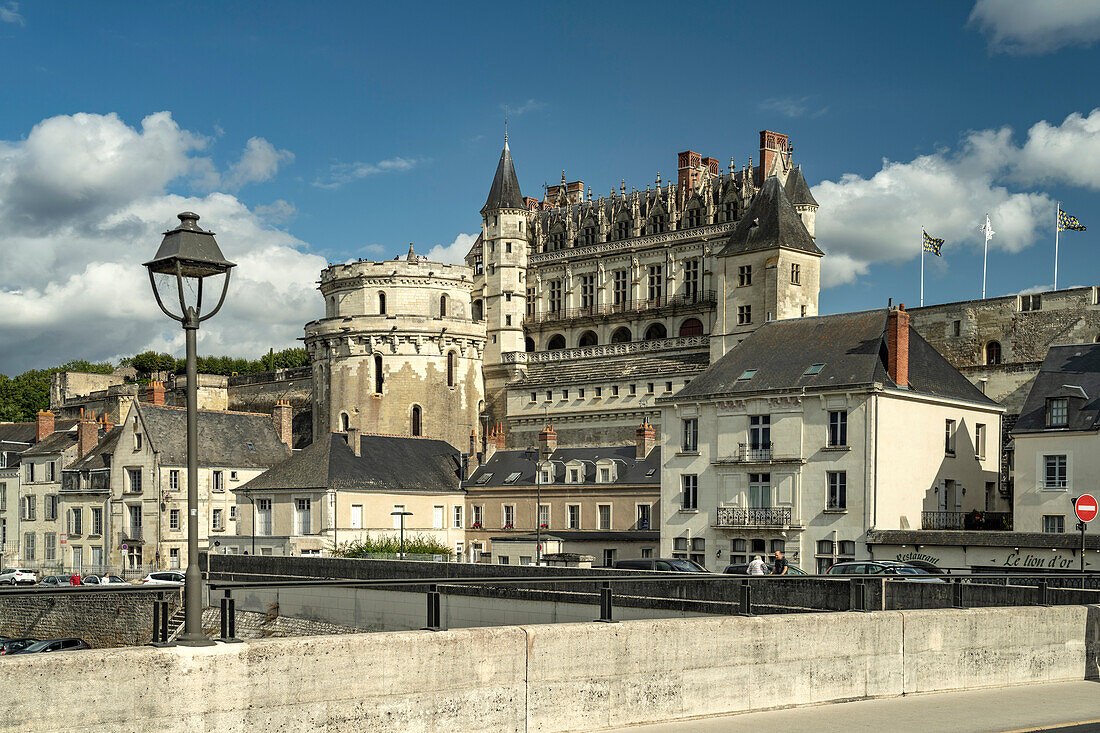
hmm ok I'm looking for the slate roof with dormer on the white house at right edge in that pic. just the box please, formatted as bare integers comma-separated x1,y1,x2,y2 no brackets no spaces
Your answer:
1012,343,1100,435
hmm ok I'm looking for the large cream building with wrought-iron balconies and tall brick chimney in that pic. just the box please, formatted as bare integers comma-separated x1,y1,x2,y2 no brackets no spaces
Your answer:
660,309,1009,572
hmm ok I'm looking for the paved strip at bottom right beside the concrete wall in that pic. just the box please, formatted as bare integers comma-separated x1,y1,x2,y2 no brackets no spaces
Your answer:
622,681,1100,733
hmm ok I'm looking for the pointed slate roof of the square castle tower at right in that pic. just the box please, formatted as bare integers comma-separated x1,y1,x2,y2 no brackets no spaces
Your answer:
719,176,825,256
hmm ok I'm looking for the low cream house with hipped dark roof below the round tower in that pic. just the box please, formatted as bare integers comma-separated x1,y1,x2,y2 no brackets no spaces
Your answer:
234,428,465,556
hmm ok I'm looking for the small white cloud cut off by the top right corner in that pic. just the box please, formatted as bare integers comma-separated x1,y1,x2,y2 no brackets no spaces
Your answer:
969,0,1100,55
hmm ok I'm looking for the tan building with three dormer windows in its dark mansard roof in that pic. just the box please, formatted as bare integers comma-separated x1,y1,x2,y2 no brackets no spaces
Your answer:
465,423,661,565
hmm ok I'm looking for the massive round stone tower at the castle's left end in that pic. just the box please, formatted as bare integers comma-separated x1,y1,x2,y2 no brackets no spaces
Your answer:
305,245,485,450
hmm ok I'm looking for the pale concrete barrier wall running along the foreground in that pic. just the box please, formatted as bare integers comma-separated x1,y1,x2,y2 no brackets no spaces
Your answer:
0,606,1100,733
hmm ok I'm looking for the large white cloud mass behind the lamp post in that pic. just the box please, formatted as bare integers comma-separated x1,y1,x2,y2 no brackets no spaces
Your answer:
0,112,325,373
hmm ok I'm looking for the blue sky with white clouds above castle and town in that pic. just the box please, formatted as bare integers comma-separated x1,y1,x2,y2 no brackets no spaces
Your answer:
0,0,1100,373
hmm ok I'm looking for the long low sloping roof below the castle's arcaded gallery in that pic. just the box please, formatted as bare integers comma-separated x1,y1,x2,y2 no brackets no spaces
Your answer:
508,351,711,389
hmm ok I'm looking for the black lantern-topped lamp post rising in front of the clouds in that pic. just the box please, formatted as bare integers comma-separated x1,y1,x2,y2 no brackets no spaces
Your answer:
145,211,235,646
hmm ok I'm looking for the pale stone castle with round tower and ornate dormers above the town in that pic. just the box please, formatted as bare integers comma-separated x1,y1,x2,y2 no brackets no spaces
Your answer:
305,131,823,450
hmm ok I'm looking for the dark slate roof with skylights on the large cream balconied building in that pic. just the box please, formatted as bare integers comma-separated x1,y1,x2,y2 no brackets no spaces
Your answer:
673,308,997,406
